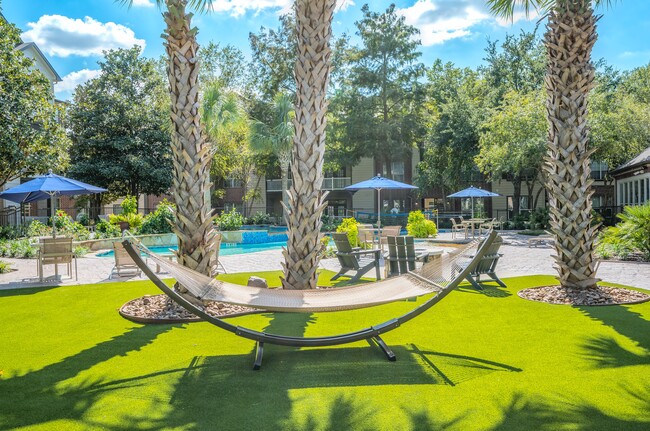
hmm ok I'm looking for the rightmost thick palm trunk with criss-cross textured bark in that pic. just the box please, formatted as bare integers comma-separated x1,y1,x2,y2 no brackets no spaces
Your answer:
545,0,598,288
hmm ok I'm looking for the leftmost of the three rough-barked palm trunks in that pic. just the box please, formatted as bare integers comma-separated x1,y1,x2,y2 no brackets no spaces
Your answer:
163,0,216,275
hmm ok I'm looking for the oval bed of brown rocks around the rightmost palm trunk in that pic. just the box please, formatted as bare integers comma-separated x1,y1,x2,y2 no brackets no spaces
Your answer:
518,285,650,306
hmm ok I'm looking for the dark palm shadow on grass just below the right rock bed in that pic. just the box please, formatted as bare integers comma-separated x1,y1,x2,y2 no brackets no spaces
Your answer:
577,305,650,368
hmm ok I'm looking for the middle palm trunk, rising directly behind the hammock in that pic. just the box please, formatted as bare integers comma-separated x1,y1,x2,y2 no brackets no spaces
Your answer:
282,0,336,289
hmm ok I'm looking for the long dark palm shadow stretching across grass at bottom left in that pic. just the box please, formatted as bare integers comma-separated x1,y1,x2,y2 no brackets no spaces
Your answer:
0,325,173,429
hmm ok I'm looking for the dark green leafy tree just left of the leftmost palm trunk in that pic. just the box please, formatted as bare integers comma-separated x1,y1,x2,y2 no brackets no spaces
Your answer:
70,47,172,208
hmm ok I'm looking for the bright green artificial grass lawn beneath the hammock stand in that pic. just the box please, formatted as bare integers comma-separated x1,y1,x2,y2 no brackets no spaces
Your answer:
0,274,650,430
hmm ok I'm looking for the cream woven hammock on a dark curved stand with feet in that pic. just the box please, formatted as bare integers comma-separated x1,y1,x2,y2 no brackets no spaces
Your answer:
123,231,497,369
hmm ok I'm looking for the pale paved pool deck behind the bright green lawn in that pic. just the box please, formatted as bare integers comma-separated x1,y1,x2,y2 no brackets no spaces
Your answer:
0,231,650,290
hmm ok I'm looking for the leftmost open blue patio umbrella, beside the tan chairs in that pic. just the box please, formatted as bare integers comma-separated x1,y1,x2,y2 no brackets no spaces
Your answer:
0,170,108,235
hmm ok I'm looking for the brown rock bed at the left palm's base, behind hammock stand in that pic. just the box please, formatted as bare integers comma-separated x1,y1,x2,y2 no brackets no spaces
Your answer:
120,294,259,323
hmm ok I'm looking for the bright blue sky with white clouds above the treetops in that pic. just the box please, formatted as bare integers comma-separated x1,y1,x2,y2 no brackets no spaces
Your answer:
1,0,650,99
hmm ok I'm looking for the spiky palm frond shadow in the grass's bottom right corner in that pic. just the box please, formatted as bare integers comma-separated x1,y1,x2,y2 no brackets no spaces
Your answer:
491,384,650,431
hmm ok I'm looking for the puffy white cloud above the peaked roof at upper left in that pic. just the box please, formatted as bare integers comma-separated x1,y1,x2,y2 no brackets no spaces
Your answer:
22,15,145,57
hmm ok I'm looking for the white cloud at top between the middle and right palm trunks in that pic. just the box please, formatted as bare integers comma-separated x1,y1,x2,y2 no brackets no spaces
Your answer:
397,0,537,46
